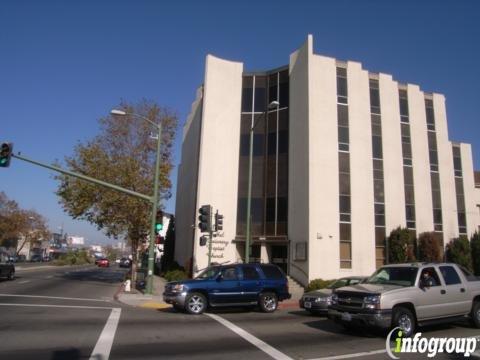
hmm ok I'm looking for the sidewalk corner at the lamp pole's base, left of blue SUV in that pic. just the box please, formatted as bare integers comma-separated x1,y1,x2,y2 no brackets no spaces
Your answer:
114,275,171,309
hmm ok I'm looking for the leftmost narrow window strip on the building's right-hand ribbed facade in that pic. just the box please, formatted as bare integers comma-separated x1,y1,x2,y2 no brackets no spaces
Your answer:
337,67,352,269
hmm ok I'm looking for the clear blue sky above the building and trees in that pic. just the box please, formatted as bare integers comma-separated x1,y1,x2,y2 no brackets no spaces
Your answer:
0,0,480,243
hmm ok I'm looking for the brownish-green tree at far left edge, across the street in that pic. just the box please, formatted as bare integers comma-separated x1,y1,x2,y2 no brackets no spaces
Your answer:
0,192,51,254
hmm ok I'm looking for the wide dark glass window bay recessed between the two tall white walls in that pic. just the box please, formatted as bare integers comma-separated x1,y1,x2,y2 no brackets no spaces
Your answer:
237,70,289,241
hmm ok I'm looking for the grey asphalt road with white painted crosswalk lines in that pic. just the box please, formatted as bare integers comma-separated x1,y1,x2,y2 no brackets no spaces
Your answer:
0,266,480,360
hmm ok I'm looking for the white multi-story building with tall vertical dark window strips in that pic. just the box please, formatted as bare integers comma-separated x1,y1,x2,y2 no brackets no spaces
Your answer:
175,36,480,283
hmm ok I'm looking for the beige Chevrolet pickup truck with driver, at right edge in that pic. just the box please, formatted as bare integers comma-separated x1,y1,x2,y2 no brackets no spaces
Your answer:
328,263,480,336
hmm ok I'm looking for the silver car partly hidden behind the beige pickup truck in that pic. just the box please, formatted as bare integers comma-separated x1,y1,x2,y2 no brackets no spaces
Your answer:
299,276,367,315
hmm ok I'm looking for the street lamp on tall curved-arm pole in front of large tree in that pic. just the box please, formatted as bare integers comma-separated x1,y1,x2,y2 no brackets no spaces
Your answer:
110,109,162,294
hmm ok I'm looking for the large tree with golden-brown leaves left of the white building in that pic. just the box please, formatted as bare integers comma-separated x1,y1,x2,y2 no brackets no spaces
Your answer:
56,100,177,281
